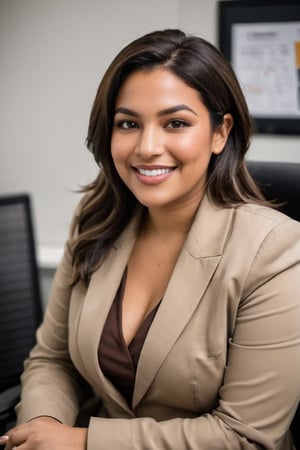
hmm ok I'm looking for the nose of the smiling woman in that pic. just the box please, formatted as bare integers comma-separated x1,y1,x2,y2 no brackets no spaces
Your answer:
135,125,163,158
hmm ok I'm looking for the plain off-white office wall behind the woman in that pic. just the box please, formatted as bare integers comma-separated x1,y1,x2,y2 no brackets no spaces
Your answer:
0,0,300,264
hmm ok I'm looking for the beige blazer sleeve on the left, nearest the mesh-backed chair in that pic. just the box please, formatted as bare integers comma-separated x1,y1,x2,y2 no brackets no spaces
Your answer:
16,198,86,425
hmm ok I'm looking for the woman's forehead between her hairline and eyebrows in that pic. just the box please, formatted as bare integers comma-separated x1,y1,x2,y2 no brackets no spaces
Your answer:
116,68,203,107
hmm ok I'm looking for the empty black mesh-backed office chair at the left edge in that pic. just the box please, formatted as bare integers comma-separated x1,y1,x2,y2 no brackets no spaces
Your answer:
0,194,42,435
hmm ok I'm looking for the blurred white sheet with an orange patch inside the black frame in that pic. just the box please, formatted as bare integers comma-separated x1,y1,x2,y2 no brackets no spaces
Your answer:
231,21,300,119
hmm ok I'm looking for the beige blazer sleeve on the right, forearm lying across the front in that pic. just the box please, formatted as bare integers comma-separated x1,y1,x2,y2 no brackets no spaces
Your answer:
87,220,300,450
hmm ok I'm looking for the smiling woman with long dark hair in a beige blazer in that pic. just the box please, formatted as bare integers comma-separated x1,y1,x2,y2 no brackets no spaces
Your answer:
1,30,300,450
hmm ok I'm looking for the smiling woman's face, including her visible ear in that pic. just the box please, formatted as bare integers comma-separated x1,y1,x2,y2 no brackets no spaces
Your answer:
111,68,232,213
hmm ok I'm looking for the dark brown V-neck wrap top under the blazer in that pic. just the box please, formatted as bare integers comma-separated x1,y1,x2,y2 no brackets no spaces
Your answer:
98,271,159,405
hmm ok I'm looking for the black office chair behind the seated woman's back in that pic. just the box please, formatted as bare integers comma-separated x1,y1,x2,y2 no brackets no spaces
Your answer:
247,161,300,450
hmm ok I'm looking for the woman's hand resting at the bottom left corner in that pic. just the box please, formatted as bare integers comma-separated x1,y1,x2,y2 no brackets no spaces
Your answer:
0,416,87,450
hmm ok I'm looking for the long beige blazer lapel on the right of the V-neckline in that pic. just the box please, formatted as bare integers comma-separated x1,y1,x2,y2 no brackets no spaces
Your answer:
132,196,233,408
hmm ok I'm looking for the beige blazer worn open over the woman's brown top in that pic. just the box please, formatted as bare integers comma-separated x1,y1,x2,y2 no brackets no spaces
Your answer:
18,197,300,450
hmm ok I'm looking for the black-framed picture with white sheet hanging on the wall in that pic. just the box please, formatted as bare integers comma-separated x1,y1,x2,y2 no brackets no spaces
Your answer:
218,0,300,135
